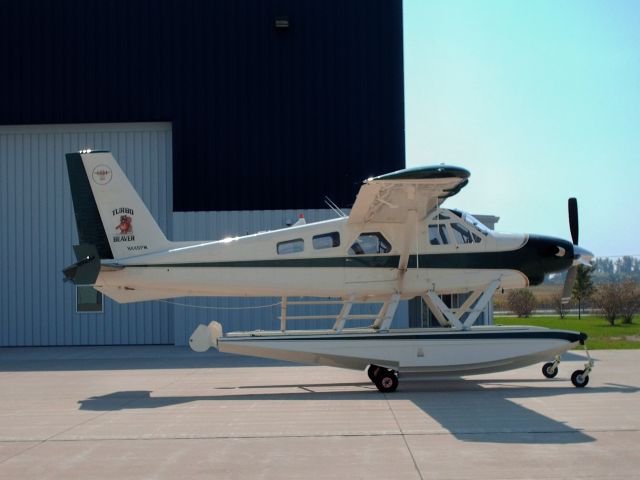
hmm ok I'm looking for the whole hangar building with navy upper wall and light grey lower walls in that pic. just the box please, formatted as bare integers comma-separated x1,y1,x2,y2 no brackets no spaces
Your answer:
0,0,406,346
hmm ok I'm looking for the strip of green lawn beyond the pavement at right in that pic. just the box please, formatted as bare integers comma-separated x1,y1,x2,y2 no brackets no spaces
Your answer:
493,316,640,350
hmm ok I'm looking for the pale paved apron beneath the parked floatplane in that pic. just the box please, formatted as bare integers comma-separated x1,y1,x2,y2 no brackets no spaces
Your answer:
0,346,640,480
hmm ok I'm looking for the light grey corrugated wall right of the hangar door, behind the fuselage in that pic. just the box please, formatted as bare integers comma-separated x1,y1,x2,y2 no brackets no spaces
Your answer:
171,210,408,345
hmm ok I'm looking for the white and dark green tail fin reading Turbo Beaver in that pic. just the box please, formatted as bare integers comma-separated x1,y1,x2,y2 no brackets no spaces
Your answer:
66,152,171,259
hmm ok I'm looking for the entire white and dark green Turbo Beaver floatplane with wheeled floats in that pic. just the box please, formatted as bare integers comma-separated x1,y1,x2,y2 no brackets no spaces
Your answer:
64,151,593,392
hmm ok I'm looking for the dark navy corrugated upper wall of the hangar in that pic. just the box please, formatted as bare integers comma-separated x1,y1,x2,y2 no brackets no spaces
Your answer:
0,0,404,211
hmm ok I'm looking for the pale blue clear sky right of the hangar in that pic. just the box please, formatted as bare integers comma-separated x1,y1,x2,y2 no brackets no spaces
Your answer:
403,0,640,256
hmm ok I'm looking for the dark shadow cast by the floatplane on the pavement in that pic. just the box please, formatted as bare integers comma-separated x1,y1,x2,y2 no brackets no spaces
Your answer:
78,379,640,444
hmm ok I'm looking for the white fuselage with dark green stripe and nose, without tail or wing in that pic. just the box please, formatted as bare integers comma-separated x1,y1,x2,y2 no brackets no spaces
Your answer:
95,209,573,302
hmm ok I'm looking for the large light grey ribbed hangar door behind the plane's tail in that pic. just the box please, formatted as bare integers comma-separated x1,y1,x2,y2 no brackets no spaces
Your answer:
0,123,174,346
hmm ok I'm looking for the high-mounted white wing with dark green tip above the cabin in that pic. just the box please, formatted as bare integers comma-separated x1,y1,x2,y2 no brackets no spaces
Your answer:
349,165,471,224
